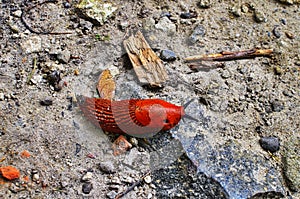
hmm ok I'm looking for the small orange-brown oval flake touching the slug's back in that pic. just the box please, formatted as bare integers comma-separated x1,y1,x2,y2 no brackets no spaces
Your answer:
97,69,116,100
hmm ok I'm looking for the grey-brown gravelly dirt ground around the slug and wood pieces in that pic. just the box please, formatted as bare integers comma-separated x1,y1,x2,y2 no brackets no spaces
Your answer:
0,0,300,198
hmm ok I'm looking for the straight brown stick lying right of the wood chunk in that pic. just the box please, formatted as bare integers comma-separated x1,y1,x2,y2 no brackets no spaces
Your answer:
184,49,273,62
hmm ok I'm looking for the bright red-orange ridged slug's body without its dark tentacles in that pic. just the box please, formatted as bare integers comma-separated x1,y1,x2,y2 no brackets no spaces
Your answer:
78,96,185,137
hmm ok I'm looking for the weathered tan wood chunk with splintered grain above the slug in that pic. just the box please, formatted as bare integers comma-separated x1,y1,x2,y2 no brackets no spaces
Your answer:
124,31,168,87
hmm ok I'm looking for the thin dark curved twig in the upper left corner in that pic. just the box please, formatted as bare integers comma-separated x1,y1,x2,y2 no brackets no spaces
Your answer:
21,0,72,35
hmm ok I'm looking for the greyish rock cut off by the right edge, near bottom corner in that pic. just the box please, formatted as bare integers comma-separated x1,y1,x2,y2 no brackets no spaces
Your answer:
282,137,300,192
